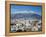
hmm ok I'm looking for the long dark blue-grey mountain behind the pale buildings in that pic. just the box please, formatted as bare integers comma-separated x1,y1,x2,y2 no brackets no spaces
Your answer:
11,13,42,20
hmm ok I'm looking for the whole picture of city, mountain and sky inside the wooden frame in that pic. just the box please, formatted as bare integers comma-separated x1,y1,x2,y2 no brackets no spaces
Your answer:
10,5,42,32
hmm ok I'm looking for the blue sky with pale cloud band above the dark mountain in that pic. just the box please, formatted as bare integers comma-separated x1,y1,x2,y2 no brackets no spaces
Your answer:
11,4,42,15
